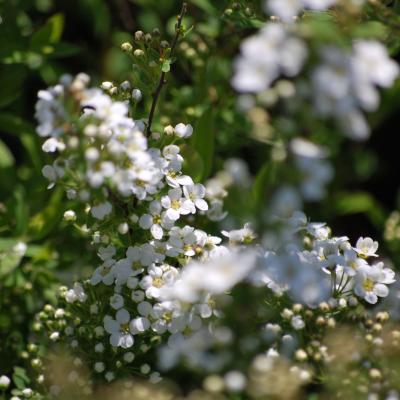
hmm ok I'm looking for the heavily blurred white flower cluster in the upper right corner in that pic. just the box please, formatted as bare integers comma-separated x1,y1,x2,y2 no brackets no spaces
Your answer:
232,16,400,140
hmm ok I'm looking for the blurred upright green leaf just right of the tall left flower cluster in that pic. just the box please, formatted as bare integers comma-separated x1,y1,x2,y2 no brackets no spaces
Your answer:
191,108,214,180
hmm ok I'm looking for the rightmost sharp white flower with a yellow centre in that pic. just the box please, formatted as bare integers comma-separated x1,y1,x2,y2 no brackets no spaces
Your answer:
354,262,395,304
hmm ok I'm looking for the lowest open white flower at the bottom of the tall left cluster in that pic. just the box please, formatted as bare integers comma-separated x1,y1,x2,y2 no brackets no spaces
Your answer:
104,308,134,349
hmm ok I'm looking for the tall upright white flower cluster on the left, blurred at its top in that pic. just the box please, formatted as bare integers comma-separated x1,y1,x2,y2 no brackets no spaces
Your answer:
37,75,240,380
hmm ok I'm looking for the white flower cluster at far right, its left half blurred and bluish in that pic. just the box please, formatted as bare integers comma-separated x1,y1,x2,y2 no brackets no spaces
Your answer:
262,212,395,306
